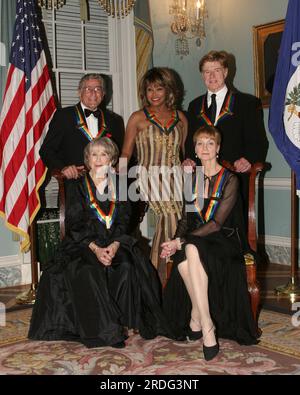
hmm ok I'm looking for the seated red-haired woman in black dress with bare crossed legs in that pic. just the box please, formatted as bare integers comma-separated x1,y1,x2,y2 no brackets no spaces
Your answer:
161,126,257,360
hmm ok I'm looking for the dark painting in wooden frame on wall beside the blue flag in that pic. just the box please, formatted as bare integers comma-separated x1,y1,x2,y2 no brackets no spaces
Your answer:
253,19,284,107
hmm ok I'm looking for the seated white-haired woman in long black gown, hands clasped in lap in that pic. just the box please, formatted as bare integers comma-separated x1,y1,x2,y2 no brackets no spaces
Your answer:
28,137,166,347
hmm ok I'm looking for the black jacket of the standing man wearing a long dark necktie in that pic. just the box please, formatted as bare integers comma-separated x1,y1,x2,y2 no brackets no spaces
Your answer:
185,91,268,163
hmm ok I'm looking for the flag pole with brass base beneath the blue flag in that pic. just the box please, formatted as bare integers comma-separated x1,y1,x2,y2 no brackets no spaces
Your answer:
275,171,300,302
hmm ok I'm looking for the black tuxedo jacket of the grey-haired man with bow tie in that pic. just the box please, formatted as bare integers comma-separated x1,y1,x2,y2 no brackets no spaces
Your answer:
40,103,125,171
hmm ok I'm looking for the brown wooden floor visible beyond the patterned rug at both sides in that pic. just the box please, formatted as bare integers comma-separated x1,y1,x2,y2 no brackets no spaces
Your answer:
0,264,300,313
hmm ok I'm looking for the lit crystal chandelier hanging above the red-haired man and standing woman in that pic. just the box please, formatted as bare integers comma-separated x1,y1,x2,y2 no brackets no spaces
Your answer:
169,0,208,58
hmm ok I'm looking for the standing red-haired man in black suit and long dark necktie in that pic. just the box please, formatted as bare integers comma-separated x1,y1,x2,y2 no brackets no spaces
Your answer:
185,51,268,240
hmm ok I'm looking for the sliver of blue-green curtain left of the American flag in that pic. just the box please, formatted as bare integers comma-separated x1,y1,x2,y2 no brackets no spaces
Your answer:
0,0,17,109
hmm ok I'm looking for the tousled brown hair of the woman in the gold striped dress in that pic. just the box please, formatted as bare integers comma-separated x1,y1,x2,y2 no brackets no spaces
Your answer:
139,67,180,110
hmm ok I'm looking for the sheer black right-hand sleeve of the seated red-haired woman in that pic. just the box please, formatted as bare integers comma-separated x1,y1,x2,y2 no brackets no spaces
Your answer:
189,174,239,237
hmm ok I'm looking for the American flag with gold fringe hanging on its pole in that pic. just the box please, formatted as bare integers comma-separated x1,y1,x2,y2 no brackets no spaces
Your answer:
0,0,56,251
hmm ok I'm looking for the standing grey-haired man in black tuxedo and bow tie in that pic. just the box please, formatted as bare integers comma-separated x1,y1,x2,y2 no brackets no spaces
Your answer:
40,74,125,179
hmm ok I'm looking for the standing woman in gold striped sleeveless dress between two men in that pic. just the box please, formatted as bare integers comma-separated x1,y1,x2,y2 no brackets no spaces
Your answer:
121,67,187,284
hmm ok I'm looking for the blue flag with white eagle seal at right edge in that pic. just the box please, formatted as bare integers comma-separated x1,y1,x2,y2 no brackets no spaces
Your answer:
269,0,300,195
